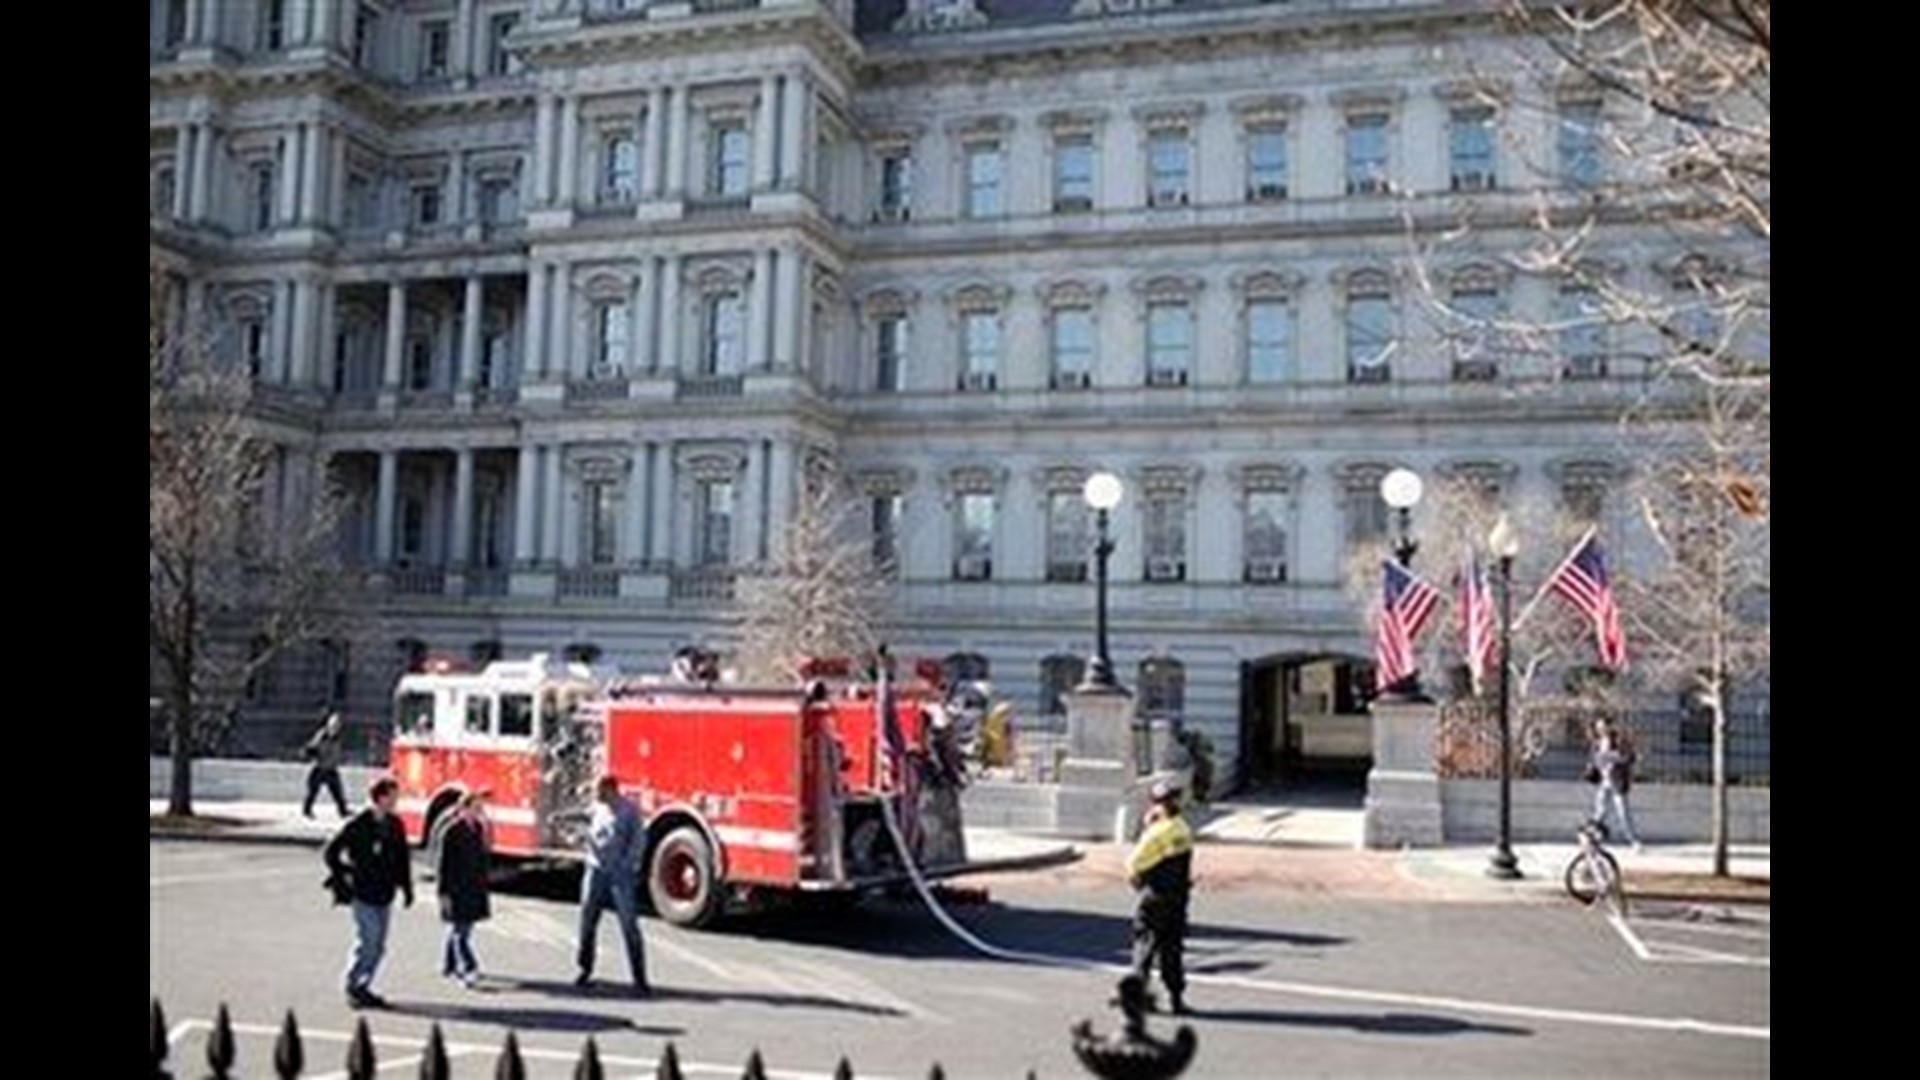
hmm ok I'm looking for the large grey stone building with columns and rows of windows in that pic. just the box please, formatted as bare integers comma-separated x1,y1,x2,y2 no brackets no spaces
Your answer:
148,0,1743,776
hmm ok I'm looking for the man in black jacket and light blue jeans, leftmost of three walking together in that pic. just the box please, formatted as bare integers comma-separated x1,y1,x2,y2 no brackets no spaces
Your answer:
324,776,413,1009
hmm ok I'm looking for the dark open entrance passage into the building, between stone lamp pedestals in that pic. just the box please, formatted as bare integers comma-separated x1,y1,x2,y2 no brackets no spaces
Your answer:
1240,653,1373,792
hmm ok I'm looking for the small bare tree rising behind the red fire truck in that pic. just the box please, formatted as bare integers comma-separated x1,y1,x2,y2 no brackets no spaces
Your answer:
739,469,891,682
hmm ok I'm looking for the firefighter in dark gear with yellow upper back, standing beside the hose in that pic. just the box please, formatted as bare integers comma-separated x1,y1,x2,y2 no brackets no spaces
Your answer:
1127,780,1194,1017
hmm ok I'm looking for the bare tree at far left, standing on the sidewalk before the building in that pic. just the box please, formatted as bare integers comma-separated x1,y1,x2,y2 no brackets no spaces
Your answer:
148,273,351,815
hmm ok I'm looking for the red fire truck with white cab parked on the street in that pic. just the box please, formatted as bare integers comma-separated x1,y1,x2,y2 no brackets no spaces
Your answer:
392,655,977,926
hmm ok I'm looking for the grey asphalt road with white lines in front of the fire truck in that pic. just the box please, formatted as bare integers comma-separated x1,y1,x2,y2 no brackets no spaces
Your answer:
148,842,1772,1080
